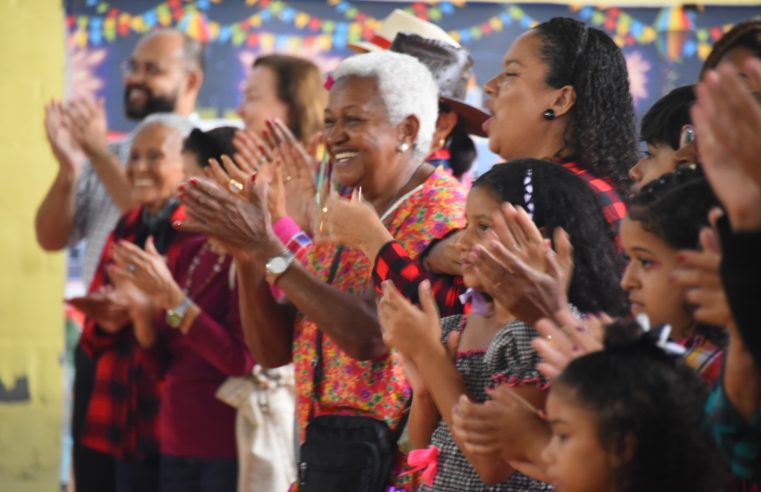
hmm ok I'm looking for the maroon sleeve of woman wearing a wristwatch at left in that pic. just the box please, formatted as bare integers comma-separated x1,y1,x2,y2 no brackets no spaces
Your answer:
185,275,254,376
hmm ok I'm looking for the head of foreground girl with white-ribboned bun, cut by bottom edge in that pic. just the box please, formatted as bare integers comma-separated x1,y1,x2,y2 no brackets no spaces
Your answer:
543,322,725,492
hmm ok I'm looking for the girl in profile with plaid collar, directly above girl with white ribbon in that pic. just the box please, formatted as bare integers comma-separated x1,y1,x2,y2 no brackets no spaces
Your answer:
621,168,727,384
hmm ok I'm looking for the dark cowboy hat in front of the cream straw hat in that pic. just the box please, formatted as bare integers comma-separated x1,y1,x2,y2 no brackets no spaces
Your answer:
390,32,489,137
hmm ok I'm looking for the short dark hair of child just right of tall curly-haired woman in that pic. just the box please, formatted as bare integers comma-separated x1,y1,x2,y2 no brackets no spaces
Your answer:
639,85,695,150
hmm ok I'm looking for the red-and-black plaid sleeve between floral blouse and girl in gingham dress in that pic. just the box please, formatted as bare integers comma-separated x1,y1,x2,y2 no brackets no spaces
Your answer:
373,241,469,317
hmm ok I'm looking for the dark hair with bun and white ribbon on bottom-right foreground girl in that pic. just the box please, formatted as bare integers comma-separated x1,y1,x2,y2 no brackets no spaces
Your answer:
552,321,727,492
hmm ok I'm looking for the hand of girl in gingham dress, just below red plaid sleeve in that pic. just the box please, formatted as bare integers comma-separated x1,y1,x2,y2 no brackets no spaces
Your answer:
378,280,441,359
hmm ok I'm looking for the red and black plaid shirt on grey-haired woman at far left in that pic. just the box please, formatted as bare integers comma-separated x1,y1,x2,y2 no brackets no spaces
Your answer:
80,206,194,458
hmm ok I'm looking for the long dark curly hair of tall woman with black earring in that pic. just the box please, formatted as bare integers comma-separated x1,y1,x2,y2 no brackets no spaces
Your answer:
535,17,639,196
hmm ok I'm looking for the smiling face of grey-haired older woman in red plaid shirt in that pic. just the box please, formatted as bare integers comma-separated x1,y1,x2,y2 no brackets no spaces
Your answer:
127,123,184,213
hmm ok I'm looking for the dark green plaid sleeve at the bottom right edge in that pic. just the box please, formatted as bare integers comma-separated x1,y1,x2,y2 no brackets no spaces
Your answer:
705,376,761,482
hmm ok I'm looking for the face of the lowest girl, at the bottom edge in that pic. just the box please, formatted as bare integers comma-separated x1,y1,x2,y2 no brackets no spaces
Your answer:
542,386,615,492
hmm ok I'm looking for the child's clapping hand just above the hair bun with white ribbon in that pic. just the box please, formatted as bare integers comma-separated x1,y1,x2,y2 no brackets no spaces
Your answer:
531,309,612,379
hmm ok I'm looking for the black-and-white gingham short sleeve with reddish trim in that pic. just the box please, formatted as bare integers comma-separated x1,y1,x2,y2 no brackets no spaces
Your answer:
484,321,549,389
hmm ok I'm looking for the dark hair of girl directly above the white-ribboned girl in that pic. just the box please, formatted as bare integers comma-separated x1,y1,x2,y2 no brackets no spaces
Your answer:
628,167,727,347
